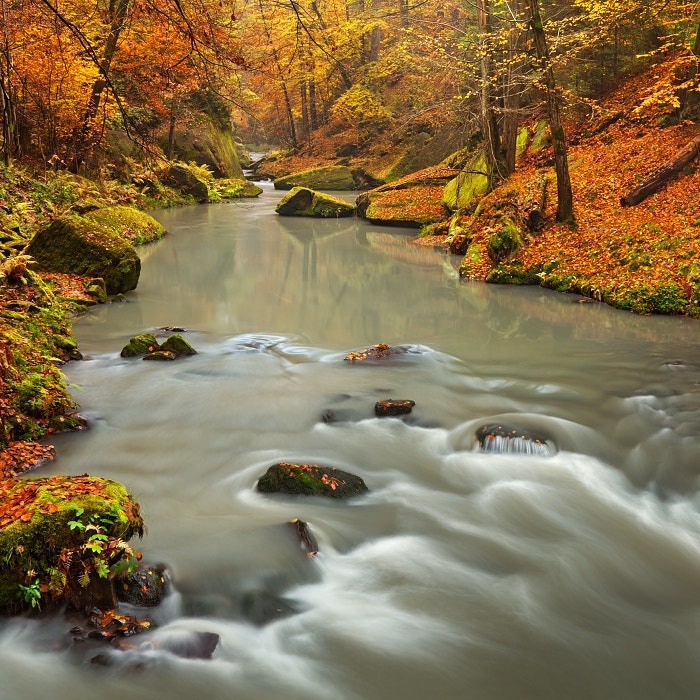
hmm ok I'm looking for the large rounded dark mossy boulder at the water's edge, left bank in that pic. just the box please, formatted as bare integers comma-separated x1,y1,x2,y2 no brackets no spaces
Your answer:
26,214,141,294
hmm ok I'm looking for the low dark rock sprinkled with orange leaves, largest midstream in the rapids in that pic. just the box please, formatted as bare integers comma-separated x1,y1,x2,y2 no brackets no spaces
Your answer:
257,462,368,498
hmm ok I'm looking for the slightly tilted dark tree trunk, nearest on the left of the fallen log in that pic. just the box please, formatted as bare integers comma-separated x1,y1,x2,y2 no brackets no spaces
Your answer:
530,0,574,221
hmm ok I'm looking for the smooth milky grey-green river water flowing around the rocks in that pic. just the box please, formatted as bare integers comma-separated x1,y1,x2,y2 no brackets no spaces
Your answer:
0,186,700,700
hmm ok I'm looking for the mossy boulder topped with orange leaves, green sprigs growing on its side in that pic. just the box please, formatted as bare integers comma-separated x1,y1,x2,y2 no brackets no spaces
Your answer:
0,476,143,612
